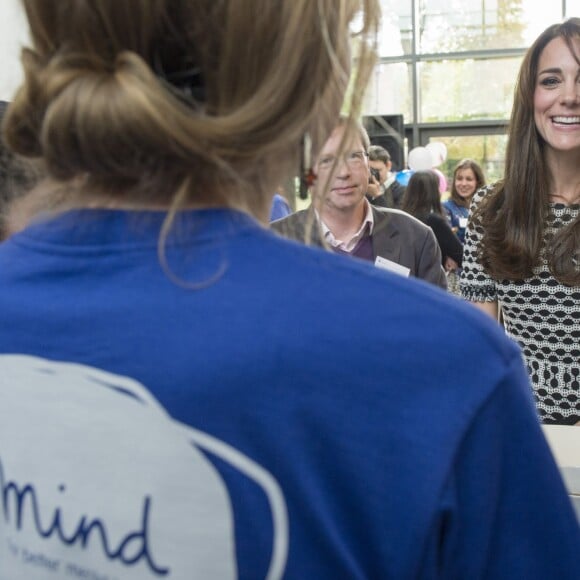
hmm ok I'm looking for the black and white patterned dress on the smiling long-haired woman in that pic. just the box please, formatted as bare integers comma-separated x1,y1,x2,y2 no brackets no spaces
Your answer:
461,187,580,423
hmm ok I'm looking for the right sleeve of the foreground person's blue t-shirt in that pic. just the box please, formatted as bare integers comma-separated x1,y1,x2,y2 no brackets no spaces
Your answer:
425,359,580,580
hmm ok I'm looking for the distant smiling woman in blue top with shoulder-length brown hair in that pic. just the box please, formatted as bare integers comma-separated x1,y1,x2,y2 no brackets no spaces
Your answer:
443,159,485,244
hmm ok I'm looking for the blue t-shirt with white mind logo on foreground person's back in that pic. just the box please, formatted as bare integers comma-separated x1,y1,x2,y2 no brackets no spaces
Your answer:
0,210,580,580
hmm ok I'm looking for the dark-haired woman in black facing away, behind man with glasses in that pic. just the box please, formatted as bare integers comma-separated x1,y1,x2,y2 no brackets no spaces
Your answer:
402,171,463,272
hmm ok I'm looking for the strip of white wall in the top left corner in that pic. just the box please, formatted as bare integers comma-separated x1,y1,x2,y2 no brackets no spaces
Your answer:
0,0,28,101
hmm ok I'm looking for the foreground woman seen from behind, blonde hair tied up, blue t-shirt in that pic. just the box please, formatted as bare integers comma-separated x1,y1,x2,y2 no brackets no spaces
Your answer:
0,0,578,580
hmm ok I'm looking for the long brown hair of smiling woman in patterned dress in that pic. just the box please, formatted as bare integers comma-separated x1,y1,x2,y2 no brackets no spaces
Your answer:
473,18,580,286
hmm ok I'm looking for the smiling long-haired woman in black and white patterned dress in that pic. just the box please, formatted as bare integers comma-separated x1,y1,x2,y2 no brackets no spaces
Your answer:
461,18,580,425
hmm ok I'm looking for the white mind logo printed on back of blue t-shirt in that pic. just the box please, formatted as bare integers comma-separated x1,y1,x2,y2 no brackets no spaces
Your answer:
0,355,288,580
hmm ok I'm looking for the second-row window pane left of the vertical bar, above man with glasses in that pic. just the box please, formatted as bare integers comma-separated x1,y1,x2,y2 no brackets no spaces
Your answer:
363,62,413,123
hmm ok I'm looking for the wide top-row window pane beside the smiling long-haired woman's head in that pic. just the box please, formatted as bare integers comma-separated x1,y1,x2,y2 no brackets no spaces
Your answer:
419,0,562,53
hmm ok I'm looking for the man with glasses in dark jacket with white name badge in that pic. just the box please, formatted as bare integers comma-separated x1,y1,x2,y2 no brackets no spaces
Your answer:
272,118,447,289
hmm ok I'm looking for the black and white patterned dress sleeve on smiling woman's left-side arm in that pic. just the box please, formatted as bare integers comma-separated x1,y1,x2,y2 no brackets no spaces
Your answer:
460,186,497,302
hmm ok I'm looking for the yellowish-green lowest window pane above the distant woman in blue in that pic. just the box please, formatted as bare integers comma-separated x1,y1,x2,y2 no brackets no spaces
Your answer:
432,135,507,191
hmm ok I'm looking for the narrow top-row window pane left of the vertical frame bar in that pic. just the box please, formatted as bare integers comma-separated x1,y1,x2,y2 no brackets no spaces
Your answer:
378,0,413,56
